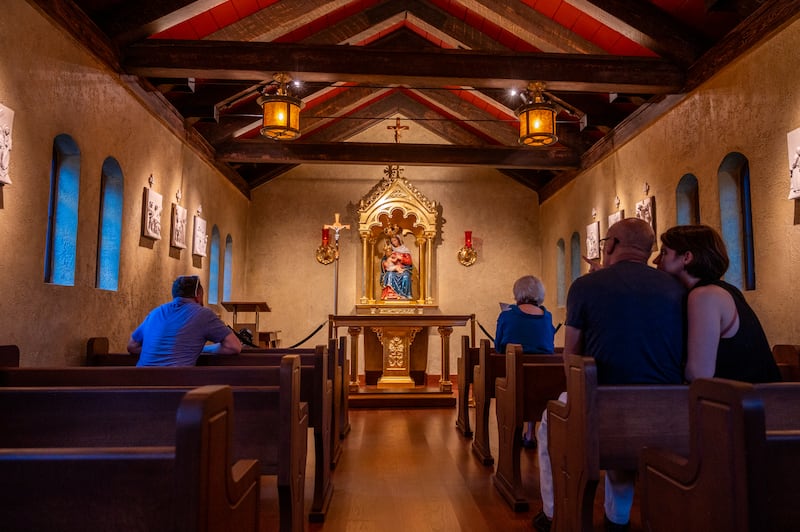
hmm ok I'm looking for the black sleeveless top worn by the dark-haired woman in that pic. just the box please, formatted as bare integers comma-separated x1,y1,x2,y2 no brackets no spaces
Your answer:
697,281,781,383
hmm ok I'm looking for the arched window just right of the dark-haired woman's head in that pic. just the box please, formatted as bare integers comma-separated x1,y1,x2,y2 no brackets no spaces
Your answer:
717,153,756,290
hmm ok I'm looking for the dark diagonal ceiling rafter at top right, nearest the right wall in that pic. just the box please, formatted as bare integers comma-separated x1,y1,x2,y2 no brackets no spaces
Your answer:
569,0,709,66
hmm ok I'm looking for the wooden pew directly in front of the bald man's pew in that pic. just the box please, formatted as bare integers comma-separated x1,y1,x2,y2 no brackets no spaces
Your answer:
492,344,566,512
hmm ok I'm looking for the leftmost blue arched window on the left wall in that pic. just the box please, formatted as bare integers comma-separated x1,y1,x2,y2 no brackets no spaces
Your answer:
44,134,81,286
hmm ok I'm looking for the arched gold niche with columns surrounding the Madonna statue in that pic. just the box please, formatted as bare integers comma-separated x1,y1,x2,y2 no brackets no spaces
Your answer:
356,165,438,314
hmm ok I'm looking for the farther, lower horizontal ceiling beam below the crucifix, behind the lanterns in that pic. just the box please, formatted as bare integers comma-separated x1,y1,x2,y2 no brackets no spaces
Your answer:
217,140,580,170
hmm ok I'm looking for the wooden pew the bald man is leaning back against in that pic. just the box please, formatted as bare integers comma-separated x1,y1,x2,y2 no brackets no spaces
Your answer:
547,355,689,532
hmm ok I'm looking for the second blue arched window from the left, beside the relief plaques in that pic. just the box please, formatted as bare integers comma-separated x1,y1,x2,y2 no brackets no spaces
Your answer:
95,157,123,290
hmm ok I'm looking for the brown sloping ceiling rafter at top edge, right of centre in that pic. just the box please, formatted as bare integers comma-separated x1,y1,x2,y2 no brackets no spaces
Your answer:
455,0,605,54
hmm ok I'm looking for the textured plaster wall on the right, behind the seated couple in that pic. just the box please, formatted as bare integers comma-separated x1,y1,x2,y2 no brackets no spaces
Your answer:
541,16,800,344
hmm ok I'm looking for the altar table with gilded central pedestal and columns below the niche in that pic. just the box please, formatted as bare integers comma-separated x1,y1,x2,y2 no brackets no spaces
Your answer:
328,314,475,392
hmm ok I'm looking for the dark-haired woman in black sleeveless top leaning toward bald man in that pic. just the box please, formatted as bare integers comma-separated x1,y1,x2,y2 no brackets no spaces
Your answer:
653,225,781,382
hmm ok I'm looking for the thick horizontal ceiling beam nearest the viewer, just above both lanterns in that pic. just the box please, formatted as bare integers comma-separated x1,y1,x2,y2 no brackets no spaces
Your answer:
124,40,685,94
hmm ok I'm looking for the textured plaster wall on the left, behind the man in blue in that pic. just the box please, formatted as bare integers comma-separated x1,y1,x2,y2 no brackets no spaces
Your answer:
0,0,248,366
